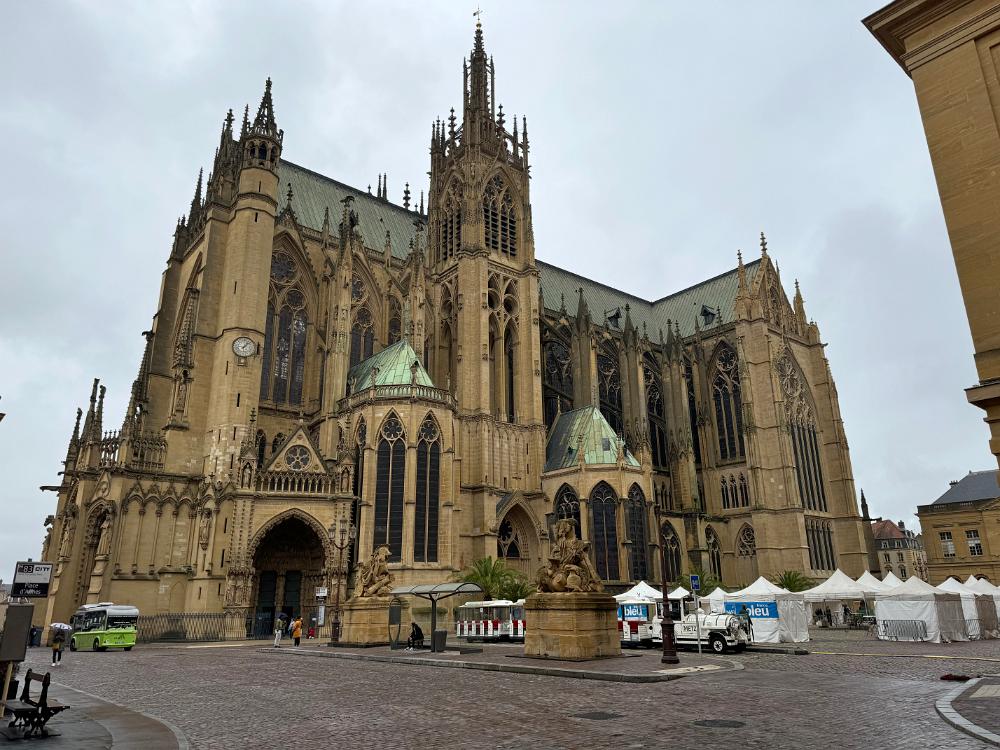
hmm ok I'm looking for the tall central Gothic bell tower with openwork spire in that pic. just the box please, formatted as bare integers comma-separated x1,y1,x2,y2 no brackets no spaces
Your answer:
428,19,545,553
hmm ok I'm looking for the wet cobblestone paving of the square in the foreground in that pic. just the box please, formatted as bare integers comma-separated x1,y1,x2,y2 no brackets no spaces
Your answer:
19,639,1000,750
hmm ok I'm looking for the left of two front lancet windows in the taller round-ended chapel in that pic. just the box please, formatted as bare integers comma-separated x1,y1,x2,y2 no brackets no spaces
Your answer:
374,414,406,562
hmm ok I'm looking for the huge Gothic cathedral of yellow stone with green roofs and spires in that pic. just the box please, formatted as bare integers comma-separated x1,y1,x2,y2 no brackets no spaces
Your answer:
42,25,867,622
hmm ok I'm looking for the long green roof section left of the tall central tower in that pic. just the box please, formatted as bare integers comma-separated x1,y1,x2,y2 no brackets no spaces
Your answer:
278,159,427,260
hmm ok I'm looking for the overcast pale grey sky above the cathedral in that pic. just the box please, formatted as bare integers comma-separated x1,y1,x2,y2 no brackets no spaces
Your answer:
0,0,994,580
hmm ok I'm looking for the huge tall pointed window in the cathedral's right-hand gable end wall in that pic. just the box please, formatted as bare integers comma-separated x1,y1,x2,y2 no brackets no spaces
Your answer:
775,349,827,511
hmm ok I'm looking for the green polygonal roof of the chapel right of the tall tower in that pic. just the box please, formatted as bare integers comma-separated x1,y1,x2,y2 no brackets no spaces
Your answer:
545,406,639,471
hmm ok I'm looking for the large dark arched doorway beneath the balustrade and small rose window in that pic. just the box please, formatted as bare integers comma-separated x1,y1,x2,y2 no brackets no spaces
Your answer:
253,515,326,623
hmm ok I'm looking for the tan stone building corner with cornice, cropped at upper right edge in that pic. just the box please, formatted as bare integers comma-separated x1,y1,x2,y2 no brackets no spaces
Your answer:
864,0,1000,470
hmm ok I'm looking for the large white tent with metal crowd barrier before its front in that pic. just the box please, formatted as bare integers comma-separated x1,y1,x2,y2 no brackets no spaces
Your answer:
875,576,969,643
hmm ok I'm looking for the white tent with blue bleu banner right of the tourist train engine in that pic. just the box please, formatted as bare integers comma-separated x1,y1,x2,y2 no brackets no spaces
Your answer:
725,577,809,643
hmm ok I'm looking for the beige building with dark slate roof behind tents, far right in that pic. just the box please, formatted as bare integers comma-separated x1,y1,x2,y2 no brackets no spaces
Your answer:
917,469,1000,585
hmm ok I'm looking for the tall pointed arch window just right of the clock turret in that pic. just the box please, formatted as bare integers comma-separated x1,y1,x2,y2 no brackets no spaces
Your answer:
260,250,309,404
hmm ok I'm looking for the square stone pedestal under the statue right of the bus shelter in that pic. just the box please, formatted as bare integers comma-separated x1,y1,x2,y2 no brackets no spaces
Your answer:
524,592,622,659
